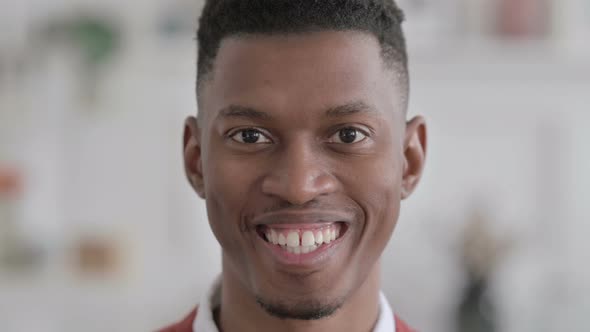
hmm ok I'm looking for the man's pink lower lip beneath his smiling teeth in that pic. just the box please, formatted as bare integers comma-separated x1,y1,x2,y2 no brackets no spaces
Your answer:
256,231,347,267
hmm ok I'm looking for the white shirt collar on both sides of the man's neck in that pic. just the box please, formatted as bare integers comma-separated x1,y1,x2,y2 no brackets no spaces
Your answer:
193,278,396,332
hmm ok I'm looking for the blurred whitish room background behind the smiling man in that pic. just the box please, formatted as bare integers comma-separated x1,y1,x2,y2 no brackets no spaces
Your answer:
0,0,590,332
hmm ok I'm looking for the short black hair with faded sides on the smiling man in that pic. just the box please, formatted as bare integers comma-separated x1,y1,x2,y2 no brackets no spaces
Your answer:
197,0,408,89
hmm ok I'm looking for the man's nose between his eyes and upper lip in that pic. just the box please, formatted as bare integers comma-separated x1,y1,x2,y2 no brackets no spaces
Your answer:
262,138,338,205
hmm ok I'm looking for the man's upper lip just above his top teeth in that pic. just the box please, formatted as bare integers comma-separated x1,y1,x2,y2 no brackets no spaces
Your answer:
252,210,352,226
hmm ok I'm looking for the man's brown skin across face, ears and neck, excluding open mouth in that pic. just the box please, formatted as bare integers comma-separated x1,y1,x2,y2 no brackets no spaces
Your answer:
184,31,426,332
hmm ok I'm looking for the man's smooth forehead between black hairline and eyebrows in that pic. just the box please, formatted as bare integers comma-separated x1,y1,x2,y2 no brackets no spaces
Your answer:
200,31,401,122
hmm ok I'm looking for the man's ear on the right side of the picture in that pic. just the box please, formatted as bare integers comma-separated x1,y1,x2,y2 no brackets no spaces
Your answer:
401,116,426,199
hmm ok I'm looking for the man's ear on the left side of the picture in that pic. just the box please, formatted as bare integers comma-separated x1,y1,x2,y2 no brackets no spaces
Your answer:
183,116,205,199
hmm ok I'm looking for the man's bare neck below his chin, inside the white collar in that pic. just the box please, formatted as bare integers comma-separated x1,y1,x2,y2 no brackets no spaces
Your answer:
216,261,380,332
